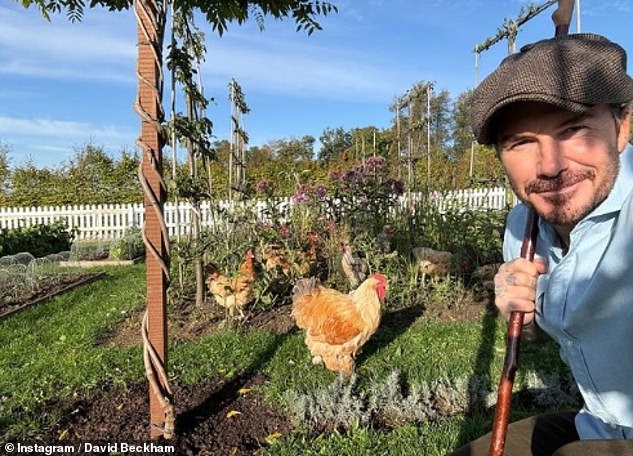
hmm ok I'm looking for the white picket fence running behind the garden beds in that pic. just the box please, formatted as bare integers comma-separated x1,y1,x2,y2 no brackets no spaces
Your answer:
0,187,515,240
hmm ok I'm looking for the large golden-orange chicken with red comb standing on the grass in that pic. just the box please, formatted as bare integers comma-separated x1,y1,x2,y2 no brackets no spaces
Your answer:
292,274,387,375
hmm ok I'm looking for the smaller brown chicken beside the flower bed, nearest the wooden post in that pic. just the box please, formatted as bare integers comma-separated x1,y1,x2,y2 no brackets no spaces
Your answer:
205,249,255,318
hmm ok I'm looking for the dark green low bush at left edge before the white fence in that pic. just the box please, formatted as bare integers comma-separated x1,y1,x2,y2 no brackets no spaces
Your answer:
0,221,73,257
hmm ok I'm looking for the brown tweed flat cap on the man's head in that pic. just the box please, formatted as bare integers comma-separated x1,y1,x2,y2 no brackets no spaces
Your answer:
471,33,633,144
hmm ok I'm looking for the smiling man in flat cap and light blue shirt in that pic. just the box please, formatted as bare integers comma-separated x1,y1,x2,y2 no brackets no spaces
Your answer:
456,34,633,456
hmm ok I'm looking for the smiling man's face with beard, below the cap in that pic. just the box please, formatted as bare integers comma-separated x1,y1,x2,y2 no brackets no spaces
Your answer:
497,102,629,233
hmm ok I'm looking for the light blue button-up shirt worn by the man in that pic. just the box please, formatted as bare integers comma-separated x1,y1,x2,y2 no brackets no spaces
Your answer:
503,145,633,439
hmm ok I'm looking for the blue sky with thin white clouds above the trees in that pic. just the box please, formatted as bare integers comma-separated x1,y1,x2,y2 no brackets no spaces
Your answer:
0,0,633,167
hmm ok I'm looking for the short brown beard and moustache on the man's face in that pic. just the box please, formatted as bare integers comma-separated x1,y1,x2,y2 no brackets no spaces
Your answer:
515,154,620,227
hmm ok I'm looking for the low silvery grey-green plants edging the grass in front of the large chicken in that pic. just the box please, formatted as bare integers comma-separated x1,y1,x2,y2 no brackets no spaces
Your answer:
285,369,576,433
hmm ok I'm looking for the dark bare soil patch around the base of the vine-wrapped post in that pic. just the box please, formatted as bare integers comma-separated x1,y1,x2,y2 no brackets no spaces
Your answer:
42,375,291,456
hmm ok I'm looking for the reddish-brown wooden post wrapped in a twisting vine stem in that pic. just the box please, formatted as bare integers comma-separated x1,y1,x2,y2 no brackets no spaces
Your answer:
134,0,174,438
